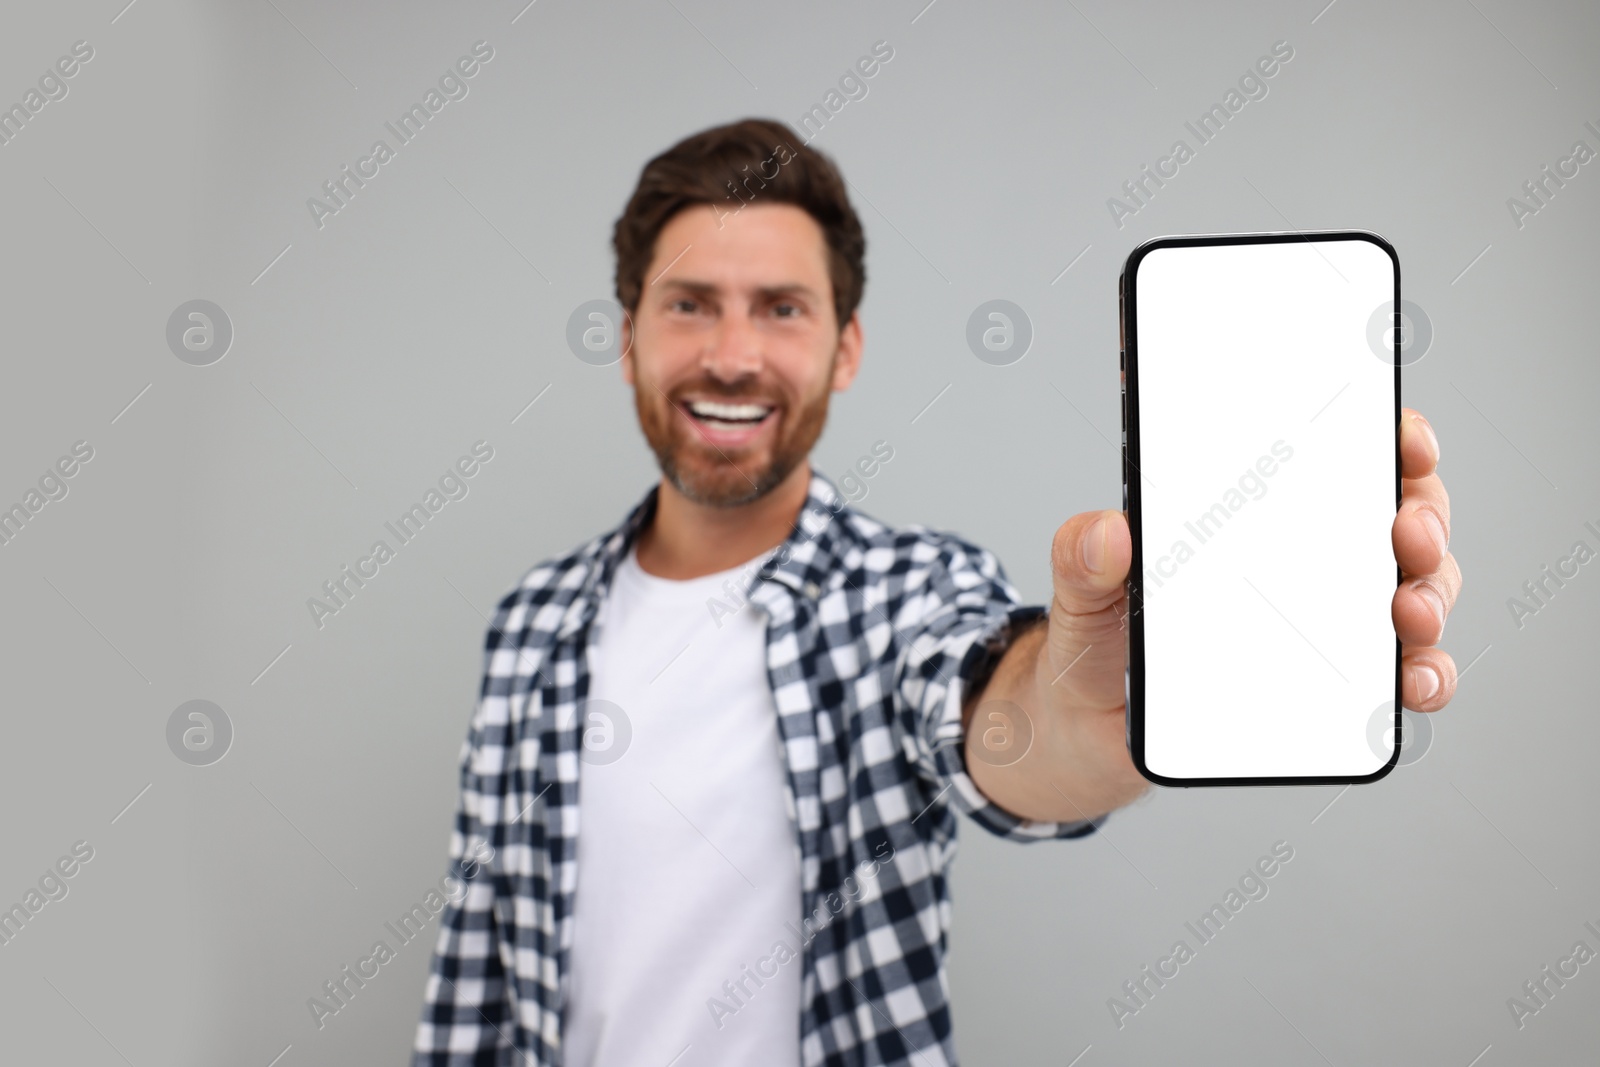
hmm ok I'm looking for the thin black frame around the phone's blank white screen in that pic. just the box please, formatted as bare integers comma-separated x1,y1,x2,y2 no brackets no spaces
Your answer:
1117,230,1403,787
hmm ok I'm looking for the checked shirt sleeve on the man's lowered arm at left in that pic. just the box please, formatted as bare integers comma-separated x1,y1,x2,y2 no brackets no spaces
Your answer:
411,702,514,1067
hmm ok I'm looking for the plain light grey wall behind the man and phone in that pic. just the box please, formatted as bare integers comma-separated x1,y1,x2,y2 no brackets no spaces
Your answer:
0,0,1600,1067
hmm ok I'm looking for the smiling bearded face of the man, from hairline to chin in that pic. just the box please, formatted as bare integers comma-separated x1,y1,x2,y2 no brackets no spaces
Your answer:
622,203,861,507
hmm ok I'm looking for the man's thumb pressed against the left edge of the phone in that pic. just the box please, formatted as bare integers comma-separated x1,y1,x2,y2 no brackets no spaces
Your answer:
1046,510,1133,707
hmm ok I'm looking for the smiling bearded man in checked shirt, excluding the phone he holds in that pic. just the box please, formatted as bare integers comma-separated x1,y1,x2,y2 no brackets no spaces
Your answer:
416,120,1461,1067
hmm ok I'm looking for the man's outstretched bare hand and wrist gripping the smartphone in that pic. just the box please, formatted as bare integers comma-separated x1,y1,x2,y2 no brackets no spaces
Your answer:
965,408,1461,821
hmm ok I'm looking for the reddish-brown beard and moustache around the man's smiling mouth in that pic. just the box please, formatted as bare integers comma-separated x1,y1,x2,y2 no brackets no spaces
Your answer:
634,355,838,507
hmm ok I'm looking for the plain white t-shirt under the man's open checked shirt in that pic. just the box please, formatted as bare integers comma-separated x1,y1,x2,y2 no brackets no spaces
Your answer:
563,550,802,1067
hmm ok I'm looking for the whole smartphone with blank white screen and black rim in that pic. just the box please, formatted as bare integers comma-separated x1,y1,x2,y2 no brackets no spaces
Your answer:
1120,230,1403,785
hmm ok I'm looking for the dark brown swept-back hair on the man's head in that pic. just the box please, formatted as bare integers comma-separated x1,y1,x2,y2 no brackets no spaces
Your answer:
611,118,867,330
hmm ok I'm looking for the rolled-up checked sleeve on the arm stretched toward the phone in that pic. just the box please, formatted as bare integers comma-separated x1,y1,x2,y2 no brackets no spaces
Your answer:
894,537,1109,841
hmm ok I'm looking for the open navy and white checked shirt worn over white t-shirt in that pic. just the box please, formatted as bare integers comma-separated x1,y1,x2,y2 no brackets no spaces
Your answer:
414,472,1104,1067
